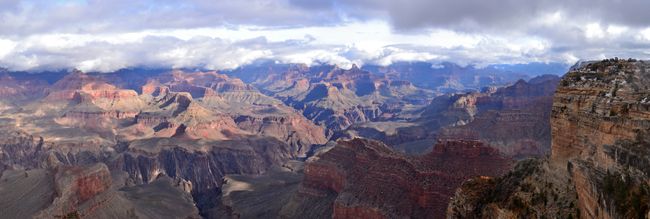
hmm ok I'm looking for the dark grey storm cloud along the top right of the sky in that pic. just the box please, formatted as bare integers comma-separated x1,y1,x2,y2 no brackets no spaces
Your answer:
337,0,650,30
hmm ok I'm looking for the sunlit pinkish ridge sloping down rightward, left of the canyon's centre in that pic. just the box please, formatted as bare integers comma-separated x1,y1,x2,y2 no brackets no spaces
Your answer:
143,71,327,156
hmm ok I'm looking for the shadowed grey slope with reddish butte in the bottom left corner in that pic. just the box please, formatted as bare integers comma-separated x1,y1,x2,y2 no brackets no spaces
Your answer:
0,164,199,218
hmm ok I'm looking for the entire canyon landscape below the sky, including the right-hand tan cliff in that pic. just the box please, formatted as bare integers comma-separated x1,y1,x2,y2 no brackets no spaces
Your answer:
0,61,636,218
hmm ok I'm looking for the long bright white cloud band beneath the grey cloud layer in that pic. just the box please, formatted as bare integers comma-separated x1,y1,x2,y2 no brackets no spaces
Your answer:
0,21,572,72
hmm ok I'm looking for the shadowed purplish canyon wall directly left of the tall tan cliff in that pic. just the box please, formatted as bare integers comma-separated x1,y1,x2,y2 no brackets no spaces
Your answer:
432,76,559,158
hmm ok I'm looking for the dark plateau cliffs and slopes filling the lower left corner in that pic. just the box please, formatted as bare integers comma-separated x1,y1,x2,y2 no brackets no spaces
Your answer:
0,129,293,218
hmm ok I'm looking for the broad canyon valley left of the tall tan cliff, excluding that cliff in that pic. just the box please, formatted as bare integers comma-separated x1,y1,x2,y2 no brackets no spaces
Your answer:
0,61,559,218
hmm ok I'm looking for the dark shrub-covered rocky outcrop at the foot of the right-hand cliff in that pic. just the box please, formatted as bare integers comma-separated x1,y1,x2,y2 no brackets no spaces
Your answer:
447,159,579,218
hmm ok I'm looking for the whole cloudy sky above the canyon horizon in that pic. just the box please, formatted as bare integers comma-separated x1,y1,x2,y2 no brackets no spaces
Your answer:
0,0,650,72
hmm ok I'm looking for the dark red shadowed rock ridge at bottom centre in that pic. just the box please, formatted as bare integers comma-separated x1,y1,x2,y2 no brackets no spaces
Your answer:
283,139,511,218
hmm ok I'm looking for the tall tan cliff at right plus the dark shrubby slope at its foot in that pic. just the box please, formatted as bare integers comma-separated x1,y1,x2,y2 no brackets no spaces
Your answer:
449,59,650,218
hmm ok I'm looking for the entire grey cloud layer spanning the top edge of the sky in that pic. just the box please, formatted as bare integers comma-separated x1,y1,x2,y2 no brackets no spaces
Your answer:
0,0,650,34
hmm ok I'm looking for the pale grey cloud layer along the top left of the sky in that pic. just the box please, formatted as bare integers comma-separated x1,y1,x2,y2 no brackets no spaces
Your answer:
0,0,339,35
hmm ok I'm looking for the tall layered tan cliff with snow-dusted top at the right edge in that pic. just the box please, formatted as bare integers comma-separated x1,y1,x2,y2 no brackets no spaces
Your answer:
551,60,650,218
